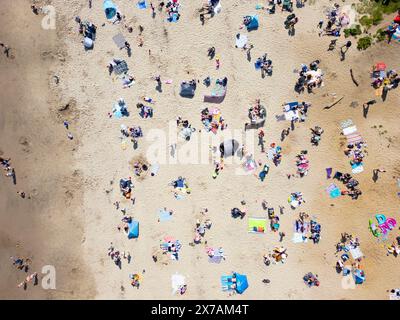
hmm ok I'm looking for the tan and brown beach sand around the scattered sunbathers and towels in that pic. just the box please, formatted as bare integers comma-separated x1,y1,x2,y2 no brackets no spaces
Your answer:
0,0,400,299
